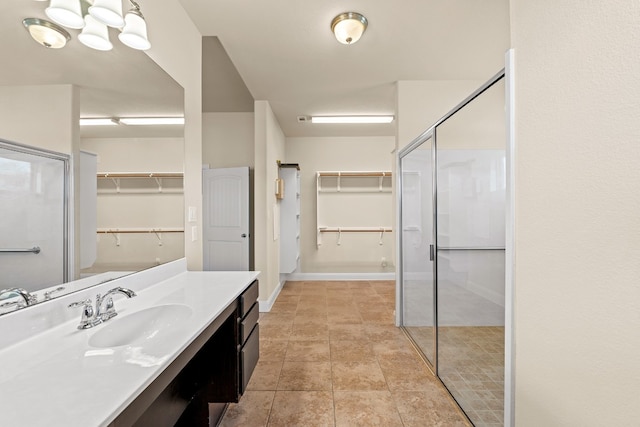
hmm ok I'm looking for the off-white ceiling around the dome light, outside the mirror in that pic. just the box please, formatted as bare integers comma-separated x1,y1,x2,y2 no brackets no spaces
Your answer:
185,0,509,136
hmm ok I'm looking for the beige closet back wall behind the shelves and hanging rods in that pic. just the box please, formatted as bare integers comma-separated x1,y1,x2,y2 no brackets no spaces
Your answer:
286,137,395,273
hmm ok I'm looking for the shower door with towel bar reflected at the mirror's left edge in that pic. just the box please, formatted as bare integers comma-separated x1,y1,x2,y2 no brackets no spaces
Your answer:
0,140,69,292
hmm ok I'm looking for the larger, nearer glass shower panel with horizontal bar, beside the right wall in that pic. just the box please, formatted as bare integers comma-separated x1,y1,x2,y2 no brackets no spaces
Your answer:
435,79,506,426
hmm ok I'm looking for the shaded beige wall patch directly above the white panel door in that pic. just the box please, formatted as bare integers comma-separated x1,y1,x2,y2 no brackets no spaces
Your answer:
202,113,255,169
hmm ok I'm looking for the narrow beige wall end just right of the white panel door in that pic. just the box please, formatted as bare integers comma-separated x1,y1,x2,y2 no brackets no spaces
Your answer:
253,101,285,302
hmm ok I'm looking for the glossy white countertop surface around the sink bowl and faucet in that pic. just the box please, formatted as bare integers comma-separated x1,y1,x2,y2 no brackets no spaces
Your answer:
0,271,258,427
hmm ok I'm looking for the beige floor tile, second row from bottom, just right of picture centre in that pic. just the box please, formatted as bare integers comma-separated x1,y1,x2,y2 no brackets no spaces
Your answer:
331,362,387,391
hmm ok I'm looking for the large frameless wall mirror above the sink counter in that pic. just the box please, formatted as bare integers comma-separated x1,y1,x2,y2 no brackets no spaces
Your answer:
0,0,184,315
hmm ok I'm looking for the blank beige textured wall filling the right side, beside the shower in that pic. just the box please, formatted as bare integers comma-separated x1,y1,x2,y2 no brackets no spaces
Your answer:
510,0,640,427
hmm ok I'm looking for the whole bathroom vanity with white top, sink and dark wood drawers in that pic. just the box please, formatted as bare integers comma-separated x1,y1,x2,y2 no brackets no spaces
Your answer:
0,260,259,427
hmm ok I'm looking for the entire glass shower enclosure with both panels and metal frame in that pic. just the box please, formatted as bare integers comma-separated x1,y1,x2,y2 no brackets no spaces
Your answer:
398,71,507,426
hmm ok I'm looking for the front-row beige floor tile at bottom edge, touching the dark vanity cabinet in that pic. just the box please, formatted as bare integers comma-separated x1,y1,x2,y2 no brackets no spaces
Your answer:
219,391,276,427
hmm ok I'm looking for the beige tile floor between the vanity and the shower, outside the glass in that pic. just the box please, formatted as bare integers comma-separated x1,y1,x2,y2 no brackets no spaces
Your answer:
221,281,470,427
